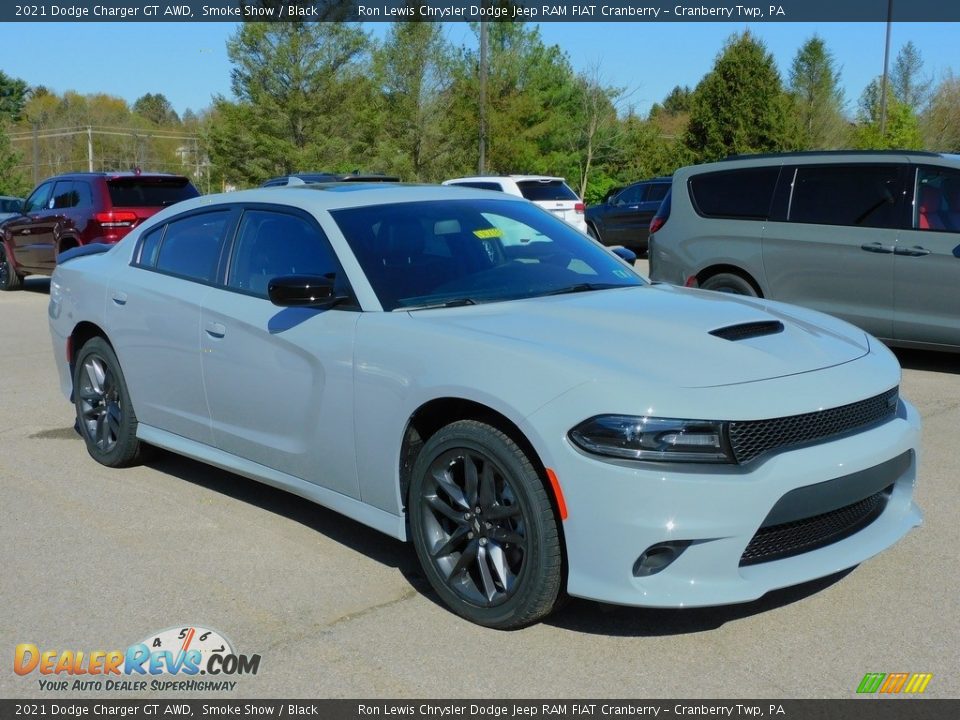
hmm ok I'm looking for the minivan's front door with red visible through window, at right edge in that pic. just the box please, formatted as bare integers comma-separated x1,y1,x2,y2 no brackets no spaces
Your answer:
893,166,960,346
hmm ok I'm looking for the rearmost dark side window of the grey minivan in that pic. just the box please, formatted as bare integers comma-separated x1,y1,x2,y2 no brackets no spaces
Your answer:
690,167,780,220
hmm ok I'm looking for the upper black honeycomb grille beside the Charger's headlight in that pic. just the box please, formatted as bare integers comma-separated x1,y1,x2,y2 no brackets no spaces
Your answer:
730,388,899,464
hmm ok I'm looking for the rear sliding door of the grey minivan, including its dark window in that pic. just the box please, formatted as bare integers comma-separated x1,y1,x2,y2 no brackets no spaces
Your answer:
763,163,908,338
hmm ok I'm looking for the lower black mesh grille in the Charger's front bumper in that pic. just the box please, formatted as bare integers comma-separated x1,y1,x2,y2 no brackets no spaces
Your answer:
740,485,893,567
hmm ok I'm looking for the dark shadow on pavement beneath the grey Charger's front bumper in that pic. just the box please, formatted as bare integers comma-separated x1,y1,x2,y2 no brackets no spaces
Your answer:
544,568,855,637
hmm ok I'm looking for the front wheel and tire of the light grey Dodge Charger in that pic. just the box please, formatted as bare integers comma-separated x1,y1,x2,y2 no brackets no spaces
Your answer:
409,420,562,630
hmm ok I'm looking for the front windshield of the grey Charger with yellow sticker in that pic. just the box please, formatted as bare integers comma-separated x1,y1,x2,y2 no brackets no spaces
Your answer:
331,199,644,310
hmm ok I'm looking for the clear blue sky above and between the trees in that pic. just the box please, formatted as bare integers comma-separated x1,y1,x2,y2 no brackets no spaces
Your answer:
0,20,960,115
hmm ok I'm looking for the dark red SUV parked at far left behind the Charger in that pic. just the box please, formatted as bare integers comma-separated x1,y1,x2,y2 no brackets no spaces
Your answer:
0,172,200,290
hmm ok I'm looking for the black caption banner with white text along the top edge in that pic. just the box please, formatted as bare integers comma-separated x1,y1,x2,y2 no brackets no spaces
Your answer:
0,0,960,24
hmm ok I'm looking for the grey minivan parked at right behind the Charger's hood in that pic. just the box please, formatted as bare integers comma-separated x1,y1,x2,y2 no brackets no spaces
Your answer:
650,151,960,352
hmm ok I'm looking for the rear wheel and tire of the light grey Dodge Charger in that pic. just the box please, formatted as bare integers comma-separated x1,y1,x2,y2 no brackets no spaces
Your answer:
73,337,142,467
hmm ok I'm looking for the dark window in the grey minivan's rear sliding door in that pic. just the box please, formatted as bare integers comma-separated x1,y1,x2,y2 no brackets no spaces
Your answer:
787,165,903,228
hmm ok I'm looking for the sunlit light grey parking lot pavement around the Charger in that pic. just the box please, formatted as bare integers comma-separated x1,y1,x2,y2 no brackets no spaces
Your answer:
0,268,960,699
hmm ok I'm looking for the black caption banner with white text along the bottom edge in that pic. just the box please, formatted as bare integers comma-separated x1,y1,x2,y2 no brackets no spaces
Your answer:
0,696,960,720
